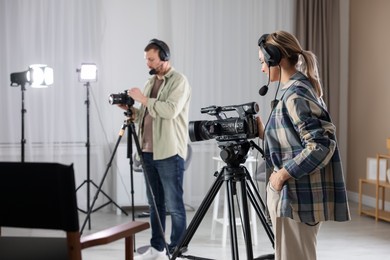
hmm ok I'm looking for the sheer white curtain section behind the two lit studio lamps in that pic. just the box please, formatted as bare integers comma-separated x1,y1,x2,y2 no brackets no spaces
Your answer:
0,0,105,208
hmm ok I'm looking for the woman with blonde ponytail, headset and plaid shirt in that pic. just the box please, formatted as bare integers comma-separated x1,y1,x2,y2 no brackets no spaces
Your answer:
258,31,350,260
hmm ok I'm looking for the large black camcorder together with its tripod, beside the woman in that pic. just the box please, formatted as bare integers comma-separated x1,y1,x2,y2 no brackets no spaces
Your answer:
171,102,274,260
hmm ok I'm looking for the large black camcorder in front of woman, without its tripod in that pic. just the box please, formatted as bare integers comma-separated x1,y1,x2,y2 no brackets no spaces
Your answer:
189,102,259,142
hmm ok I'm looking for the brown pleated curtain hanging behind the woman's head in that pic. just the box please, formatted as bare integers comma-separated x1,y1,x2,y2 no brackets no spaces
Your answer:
295,0,341,126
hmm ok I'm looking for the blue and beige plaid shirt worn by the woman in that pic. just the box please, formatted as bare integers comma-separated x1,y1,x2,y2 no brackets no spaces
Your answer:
264,73,350,223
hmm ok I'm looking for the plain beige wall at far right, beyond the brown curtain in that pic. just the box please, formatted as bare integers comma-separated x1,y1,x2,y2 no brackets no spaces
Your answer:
347,0,390,201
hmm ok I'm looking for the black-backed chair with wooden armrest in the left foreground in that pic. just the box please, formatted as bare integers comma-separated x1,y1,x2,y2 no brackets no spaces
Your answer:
0,162,149,260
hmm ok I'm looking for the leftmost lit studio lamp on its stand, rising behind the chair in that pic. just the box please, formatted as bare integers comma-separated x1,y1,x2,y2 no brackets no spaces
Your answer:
10,64,53,163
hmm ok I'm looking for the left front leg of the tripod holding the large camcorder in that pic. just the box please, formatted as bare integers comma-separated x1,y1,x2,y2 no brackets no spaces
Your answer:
171,169,224,260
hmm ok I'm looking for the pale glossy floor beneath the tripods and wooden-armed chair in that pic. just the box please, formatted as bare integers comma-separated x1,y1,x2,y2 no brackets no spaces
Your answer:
3,202,390,260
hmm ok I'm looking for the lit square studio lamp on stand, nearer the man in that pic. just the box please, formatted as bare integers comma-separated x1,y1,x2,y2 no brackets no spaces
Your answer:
76,63,127,230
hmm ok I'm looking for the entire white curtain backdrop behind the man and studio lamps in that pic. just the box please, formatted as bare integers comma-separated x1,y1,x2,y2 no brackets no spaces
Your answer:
0,0,294,207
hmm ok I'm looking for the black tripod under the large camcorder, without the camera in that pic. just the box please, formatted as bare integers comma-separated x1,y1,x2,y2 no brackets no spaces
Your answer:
171,140,274,260
